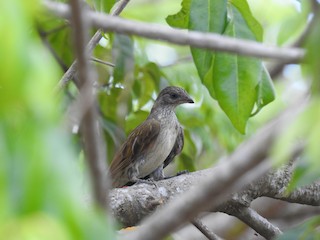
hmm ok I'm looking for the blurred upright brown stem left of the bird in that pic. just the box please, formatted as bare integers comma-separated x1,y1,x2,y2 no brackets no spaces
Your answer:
70,0,109,209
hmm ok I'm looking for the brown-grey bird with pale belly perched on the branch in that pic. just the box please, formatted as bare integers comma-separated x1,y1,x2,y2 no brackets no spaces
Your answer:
109,86,194,188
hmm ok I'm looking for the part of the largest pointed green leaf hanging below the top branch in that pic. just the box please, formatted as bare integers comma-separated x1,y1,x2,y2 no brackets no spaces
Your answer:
212,53,260,133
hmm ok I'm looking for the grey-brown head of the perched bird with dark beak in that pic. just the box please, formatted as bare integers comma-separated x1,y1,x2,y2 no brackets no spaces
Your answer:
153,86,194,109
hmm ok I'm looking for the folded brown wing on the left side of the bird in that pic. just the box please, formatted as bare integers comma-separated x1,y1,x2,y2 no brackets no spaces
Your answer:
110,119,160,178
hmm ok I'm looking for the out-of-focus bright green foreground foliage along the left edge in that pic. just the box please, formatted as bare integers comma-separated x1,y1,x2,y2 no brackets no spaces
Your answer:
0,0,113,239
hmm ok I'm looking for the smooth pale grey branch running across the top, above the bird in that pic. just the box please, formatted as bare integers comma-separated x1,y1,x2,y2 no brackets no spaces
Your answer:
45,2,305,62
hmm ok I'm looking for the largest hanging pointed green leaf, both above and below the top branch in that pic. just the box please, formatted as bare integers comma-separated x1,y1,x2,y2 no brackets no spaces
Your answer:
208,5,262,133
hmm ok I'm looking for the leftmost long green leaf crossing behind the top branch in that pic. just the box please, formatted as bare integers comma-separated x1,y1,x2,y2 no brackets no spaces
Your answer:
189,0,227,79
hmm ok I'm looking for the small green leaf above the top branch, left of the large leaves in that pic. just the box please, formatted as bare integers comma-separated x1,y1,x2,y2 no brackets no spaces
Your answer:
166,0,191,28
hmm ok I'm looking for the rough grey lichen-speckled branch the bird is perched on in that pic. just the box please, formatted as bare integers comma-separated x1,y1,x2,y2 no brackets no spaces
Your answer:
110,161,320,239
